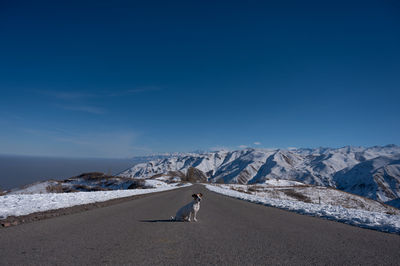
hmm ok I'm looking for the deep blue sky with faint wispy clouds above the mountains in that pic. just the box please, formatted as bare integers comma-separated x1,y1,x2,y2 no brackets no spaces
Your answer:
0,0,400,157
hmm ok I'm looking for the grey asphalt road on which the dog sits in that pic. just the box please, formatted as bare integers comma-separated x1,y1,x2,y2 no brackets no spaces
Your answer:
0,185,400,265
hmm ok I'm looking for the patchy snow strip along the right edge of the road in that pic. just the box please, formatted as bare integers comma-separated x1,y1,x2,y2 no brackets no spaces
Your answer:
205,185,400,234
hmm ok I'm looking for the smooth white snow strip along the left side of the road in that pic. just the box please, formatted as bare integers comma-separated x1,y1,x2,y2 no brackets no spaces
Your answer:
0,184,191,219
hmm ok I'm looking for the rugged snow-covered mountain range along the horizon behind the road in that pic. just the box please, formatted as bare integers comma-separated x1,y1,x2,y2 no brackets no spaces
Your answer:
119,145,400,206
